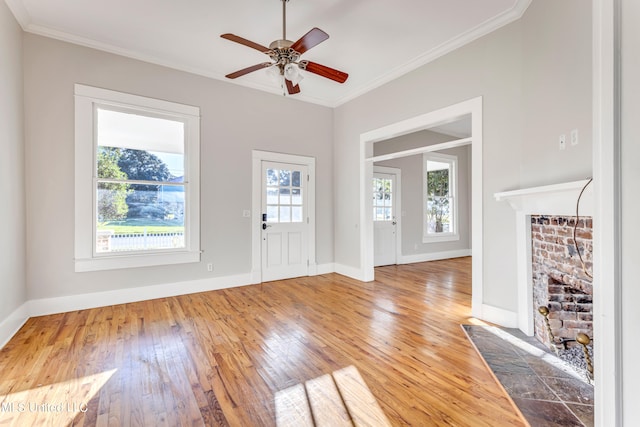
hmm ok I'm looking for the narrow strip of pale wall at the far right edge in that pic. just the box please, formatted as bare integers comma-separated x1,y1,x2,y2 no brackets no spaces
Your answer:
620,0,640,426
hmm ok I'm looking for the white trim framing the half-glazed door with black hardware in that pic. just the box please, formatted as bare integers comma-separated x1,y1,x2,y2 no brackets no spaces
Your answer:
251,150,318,283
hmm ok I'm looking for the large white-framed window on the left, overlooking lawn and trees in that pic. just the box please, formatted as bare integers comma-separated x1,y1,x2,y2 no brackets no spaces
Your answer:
75,85,200,271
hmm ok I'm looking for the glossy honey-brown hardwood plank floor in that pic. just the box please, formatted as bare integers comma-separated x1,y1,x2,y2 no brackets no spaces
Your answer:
0,258,525,426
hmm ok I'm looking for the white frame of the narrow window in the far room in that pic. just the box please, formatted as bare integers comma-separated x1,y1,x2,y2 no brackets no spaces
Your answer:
422,152,460,243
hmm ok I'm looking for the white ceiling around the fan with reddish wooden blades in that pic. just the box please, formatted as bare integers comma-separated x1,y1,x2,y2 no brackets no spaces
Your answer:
5,0,531,107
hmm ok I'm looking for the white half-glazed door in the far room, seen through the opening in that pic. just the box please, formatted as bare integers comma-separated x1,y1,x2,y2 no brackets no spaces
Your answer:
373,172,398,267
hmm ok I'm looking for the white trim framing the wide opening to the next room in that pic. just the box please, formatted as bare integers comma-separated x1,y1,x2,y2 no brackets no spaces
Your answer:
360,96,484,318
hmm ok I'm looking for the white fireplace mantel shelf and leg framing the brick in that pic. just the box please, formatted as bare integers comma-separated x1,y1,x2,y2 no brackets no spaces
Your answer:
494,179,594,336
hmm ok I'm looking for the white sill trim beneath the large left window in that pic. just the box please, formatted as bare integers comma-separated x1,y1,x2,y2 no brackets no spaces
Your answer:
75,251,200,273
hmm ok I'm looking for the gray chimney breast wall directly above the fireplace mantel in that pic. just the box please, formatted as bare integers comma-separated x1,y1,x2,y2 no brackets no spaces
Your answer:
520,0,593,187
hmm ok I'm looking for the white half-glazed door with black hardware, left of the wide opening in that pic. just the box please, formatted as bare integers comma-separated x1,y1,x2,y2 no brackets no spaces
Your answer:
261,161,309,282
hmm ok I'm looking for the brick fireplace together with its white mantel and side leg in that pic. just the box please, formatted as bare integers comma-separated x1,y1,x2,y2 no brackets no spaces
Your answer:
494,180,593,342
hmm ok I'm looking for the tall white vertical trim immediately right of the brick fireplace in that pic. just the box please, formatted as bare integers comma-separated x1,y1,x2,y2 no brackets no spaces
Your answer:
592,0,624,426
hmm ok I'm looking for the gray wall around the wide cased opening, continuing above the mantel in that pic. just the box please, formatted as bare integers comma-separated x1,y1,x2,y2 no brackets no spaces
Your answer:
334,0,591,312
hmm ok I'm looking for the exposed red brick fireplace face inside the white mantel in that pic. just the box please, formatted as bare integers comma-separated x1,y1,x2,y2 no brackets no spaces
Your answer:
531,215,593,346
